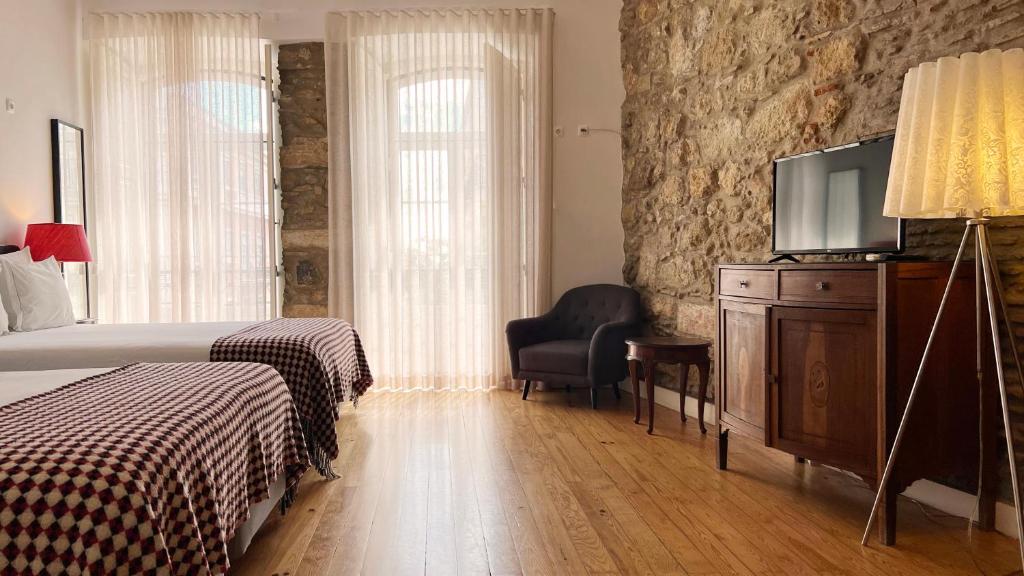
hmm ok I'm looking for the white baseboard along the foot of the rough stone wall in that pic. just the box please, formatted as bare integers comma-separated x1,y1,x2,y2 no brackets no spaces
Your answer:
618,382,1017,538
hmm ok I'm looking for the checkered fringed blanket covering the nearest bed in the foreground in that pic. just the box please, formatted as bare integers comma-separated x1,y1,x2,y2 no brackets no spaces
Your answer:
0,363,308,574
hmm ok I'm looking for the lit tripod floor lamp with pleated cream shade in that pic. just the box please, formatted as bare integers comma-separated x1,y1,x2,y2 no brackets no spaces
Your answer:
861,44,1024,566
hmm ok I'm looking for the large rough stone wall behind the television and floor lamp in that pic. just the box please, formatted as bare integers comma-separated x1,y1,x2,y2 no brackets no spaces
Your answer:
621,0,1024,403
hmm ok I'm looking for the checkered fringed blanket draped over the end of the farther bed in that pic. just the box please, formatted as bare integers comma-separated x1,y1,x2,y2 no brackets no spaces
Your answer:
210,318,374,478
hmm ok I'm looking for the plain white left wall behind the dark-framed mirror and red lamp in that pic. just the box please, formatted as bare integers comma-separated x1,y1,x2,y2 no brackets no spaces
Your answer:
0,0,80,244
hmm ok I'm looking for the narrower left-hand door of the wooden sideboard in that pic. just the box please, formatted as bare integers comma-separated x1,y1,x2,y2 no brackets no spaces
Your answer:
718,300,771,439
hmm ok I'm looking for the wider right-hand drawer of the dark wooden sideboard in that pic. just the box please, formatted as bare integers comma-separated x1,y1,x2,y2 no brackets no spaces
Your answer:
778,270,879,304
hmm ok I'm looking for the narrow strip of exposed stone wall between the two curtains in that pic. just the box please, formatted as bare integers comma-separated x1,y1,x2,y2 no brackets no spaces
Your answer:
278,42,328,317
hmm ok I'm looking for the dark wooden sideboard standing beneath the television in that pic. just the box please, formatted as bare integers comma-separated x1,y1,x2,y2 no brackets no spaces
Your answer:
716,262,999,544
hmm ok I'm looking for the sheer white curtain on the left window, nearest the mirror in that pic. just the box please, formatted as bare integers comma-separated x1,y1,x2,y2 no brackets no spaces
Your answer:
88,13,272,322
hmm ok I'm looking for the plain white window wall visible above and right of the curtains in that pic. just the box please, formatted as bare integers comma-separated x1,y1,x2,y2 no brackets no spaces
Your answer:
83,0,625,297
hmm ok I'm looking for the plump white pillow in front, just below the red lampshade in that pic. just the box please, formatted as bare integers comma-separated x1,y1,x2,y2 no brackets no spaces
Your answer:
3,256,75,332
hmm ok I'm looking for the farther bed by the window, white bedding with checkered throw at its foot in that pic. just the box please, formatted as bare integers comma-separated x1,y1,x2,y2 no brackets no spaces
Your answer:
0,318,373,478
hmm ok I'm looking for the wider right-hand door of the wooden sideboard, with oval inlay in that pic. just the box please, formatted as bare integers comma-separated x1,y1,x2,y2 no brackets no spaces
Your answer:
768,306,879,477
